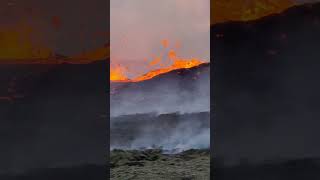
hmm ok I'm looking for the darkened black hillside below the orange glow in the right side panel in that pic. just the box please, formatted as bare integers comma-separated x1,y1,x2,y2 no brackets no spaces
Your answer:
211,3,320,162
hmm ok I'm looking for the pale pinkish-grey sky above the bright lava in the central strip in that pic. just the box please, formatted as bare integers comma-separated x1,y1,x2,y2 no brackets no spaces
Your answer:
110,0,210,76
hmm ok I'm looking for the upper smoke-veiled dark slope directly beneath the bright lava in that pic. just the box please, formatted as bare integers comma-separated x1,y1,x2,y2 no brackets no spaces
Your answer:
110,65,210,117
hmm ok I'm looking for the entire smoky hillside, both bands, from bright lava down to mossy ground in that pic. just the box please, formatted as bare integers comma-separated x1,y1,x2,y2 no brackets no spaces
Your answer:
110,64,210,153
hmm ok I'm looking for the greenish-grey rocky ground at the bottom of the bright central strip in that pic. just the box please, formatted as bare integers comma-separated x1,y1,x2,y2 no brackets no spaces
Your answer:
110,149,210,180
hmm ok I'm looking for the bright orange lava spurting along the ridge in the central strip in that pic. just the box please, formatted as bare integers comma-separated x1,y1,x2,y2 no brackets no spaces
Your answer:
110,42,204,82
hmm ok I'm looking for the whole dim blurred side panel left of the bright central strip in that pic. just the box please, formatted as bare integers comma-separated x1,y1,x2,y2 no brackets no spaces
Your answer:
0,0,110,180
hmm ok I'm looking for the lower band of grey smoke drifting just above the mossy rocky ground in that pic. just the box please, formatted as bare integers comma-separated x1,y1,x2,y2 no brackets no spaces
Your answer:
110,112,210,153
